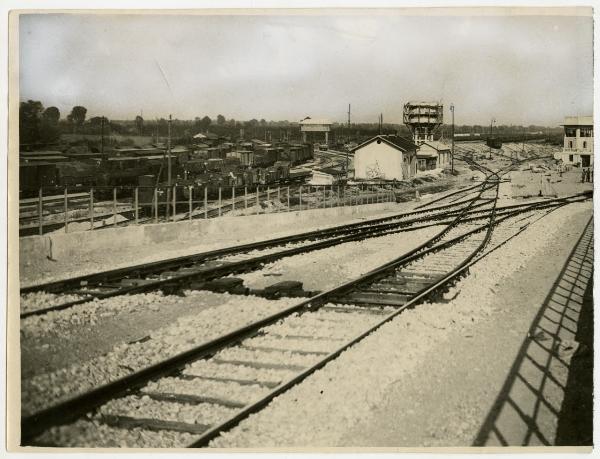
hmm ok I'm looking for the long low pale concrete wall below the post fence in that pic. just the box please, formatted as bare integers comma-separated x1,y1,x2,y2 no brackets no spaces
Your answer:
19,202,397,263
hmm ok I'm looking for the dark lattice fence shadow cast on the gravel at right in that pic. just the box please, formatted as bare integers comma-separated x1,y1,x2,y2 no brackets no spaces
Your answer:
473,218,594,446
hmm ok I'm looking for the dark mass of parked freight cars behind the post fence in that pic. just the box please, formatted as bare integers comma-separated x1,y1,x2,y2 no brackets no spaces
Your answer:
19,144,312,197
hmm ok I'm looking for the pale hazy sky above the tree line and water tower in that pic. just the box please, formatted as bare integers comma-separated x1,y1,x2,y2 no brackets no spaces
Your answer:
19,10,593,126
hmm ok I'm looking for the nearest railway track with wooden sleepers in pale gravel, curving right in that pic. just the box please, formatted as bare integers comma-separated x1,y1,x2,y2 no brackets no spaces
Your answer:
22,161,584,447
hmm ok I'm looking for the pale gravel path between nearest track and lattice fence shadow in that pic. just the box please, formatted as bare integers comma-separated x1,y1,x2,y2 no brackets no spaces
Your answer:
212,203,591,448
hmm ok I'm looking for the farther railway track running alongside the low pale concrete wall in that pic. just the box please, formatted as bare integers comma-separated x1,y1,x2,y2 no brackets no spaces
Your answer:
20,187,496,319
